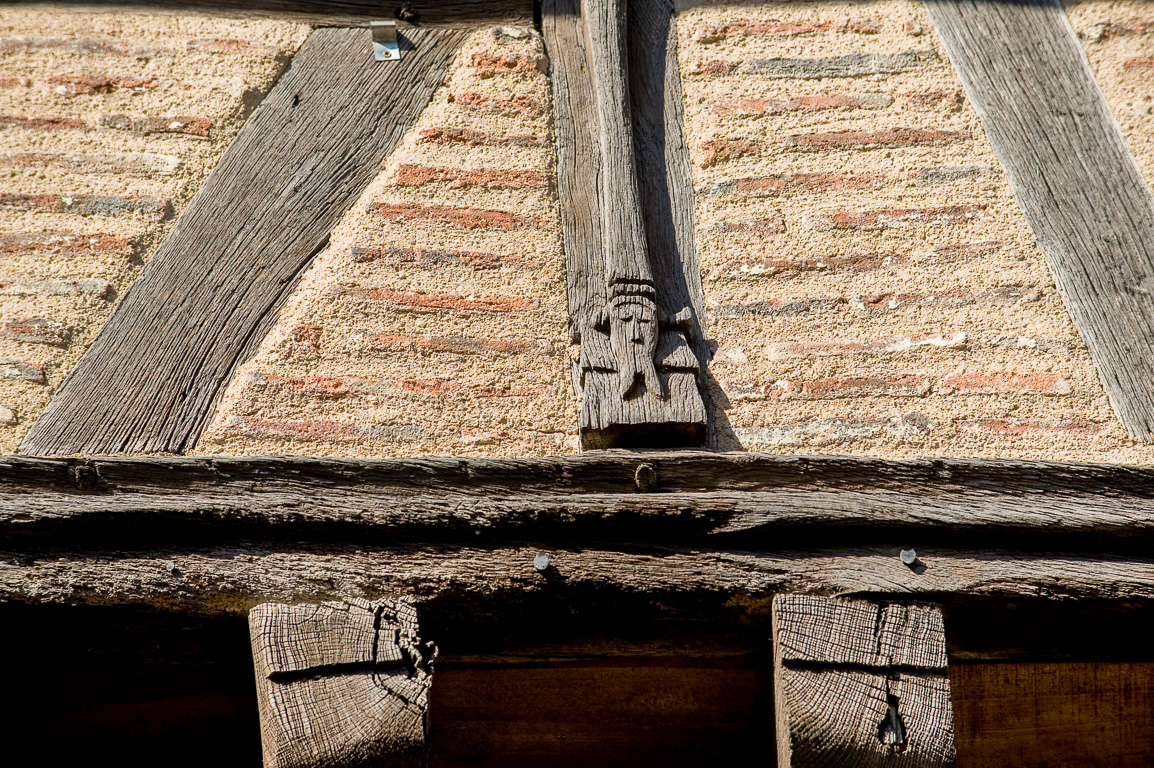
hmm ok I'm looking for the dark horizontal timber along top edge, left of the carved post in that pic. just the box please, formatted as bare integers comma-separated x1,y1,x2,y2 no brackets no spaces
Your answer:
10,0,533,27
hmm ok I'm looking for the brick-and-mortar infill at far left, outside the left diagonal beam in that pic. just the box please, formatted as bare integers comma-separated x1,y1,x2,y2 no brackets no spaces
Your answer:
0,8,308,453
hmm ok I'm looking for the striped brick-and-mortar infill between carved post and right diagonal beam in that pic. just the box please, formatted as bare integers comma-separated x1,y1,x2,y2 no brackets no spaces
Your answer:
679,0,1154,462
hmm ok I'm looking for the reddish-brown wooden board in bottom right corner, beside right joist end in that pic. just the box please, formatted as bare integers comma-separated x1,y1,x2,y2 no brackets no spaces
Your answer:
950,659,1154,768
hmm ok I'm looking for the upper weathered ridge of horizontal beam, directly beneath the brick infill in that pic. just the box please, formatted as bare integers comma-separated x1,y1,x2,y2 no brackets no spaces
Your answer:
11,452,1154,551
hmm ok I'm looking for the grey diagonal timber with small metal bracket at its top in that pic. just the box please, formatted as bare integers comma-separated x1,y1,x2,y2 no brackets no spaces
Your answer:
21,29,464,454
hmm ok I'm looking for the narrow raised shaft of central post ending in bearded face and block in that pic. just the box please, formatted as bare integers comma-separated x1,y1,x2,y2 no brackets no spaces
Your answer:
577,0,706,449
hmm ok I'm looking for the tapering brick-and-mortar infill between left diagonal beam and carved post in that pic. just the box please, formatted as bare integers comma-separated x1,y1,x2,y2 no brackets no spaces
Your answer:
197,28,578,457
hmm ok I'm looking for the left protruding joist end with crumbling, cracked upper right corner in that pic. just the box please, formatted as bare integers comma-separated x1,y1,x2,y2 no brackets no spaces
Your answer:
248,600,434,768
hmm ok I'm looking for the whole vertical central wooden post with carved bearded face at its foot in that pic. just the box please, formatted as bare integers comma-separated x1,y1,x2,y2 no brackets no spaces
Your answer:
545,0,707,449
